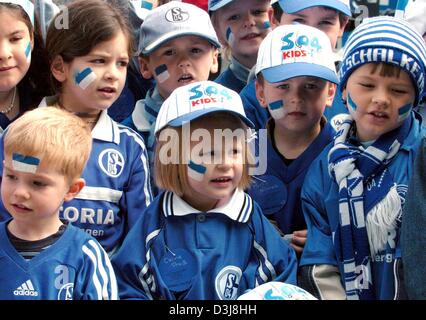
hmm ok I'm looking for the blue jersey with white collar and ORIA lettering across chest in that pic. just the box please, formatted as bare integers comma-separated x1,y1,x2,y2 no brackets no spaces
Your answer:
0,100,152,254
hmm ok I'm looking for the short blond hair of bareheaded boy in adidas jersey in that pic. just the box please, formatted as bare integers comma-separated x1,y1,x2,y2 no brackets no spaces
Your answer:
4,107,92,180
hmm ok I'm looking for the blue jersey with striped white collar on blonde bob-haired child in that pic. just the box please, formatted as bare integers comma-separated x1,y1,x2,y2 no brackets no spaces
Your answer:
112,191,297,300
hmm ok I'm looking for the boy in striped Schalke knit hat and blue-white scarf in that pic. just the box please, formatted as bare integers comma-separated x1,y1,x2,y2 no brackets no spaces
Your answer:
300,17,426,300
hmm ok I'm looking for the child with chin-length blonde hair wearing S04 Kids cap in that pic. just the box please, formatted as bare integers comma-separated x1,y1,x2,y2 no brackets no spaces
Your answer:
112,81,297,300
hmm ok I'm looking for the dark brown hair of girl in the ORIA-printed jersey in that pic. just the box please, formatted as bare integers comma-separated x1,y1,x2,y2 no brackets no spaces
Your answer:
46,0,135,91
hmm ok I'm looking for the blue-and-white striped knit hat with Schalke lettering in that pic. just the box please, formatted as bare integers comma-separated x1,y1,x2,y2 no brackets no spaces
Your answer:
339,16,426,106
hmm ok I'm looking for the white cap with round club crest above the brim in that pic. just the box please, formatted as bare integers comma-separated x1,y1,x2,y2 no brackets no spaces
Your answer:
139,1,220,56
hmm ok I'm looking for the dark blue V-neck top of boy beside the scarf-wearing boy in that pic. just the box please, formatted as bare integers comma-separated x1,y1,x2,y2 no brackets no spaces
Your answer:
247,119,335,234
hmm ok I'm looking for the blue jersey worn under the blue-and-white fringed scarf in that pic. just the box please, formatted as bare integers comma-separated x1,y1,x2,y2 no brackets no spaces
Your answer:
300,113,425,299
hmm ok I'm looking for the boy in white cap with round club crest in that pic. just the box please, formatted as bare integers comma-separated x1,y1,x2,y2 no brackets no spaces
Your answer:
122,1,220,166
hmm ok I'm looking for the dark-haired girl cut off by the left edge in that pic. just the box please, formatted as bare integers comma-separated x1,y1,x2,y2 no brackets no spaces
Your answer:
0,0,49,132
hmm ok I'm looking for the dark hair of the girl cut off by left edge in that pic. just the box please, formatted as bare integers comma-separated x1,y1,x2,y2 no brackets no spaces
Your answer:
0,3,50,109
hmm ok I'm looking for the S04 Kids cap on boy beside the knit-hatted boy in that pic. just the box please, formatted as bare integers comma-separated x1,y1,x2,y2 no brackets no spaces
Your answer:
256,24,338,84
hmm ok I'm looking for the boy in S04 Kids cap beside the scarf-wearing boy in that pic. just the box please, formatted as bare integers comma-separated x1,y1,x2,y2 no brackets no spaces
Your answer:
249,25,338,254
